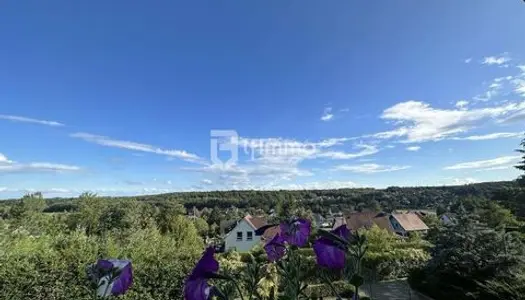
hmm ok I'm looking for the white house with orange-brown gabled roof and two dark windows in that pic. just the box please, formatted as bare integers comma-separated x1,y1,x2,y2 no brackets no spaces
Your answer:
224,215,268,252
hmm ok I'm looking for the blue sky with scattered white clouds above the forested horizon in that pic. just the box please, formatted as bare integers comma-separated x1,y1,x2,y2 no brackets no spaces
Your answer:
0,0,525,198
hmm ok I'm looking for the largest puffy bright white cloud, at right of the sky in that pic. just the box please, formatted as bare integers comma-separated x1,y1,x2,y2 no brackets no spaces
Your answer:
371,101,525,143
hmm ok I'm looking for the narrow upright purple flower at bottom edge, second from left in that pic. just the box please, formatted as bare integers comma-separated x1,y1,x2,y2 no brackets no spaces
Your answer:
184,247,219,300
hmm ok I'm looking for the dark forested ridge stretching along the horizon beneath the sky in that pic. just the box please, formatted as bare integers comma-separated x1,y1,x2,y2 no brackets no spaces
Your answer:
13,181,525,217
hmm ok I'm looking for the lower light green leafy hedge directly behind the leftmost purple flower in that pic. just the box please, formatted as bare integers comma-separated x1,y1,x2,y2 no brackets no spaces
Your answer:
0,221,204,300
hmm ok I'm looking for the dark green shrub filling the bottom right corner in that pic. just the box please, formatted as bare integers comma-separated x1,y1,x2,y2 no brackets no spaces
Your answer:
410,215,525,300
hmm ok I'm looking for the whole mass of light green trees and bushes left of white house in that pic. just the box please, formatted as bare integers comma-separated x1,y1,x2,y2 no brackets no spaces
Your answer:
0,194,204,300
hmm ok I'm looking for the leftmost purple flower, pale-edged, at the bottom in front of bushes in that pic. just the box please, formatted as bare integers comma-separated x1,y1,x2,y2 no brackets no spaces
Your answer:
96,259,133,297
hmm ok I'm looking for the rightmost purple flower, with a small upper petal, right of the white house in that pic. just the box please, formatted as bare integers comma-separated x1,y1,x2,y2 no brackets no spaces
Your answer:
313,225,350,269
